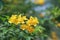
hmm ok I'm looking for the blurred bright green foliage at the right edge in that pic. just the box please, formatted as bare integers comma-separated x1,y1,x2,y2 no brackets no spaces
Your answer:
48,7,60,22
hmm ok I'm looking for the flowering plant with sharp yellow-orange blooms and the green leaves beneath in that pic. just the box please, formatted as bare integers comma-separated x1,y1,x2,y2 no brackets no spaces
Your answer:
0,14,45,40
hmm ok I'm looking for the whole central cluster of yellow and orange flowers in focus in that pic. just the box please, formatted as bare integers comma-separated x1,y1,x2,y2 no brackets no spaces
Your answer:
8,15,39,33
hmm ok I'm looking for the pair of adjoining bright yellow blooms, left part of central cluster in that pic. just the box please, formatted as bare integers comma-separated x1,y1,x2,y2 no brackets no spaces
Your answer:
9,15,27,25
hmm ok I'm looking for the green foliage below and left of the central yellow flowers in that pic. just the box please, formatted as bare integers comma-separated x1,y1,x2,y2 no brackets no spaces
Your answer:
0,15,45,40
